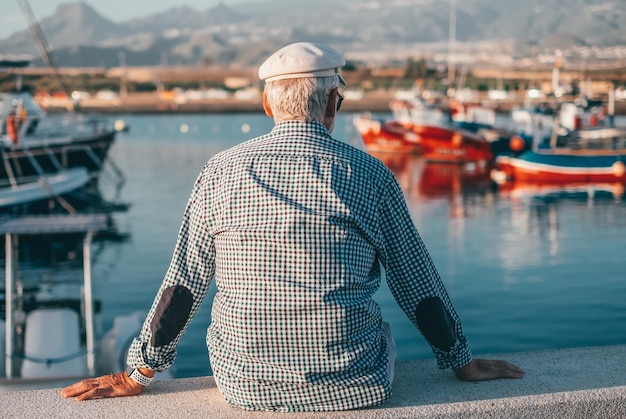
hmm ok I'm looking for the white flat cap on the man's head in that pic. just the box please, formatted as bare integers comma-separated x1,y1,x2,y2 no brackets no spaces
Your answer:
259,42,346,86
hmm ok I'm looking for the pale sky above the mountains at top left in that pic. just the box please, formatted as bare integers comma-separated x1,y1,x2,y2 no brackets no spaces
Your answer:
0,0,256,39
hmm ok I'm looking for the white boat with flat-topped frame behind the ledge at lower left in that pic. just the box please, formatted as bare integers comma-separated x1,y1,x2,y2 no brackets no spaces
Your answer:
0,214,170,391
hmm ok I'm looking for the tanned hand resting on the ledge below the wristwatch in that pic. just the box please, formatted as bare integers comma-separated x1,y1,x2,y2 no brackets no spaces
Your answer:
61,372,144,401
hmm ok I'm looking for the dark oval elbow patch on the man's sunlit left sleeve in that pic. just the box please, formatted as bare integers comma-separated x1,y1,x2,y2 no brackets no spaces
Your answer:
150,285,193,346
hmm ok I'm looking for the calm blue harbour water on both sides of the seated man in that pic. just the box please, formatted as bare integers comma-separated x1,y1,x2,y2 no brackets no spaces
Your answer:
80,114,626,377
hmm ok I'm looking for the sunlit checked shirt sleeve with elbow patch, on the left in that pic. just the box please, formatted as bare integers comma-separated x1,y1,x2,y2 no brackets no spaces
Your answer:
126,167,215,371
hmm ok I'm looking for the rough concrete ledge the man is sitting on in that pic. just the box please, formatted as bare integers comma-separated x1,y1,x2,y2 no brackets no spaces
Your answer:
0,345,626,419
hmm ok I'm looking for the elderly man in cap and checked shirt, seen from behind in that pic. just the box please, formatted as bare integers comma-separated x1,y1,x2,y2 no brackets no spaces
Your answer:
62,42,524,411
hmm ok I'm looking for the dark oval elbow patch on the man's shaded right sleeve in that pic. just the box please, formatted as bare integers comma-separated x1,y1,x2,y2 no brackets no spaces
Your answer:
415,297,456,352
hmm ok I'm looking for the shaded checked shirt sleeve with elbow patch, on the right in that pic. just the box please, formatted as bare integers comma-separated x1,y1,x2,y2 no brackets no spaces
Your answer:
379,176,472,369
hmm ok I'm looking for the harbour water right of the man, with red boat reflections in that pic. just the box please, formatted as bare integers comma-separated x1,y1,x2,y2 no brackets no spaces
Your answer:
366,149,626,359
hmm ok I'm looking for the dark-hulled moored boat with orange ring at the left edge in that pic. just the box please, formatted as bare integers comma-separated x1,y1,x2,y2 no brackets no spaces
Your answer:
0,91,124,215
